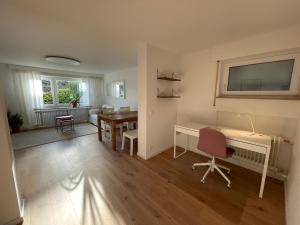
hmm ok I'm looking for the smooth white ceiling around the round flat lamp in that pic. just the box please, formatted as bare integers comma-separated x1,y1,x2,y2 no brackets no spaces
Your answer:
0,0,300,73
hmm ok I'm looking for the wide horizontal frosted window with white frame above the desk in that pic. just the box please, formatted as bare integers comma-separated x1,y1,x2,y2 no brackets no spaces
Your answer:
220,54,300,96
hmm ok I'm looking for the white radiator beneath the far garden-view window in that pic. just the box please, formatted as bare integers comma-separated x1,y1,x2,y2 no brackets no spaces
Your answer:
35,107,90,127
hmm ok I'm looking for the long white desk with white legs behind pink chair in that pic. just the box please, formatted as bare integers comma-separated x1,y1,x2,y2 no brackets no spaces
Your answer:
174,123,271,198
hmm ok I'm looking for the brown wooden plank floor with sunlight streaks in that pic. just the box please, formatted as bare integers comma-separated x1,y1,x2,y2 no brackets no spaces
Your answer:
16,134,284,225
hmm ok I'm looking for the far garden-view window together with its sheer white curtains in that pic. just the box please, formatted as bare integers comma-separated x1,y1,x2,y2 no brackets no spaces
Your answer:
9,67,103,128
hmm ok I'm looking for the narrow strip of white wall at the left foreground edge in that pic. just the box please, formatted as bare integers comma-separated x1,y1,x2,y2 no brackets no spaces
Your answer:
0,80,21,224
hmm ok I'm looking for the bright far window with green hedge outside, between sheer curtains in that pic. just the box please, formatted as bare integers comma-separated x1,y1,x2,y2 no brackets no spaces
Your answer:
42,77,89,106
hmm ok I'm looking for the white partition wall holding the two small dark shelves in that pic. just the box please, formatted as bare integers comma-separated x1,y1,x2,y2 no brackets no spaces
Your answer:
138,44,179,159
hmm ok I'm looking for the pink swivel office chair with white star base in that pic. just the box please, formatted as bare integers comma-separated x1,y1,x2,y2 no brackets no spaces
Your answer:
192,128,234,188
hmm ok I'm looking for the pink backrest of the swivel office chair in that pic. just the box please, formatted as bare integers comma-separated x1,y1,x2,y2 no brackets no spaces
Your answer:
197,127,227,158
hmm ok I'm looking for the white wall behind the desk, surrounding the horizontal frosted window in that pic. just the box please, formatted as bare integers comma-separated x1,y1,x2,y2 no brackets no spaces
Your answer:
177,27,300,225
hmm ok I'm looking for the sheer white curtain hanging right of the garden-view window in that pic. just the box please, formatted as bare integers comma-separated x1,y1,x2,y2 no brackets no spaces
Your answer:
87,77,103,108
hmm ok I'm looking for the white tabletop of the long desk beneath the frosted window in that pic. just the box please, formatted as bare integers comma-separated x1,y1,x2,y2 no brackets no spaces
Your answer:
176,122,271,147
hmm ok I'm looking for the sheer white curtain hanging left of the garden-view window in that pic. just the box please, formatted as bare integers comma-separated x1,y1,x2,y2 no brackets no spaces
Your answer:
12,70,43,128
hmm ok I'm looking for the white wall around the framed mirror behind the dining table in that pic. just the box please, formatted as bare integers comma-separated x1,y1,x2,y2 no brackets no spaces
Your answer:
104,67,138,110
